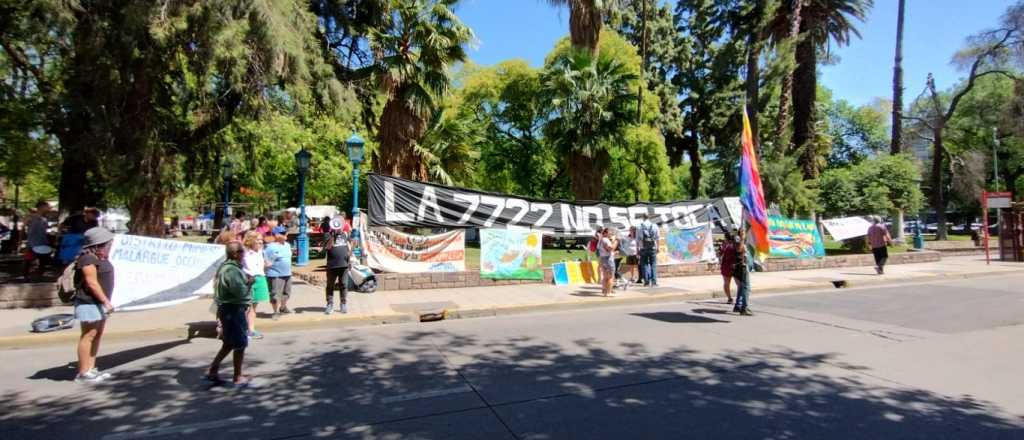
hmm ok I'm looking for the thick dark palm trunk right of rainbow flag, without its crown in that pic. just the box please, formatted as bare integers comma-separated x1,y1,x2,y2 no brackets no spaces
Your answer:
793,29,818,179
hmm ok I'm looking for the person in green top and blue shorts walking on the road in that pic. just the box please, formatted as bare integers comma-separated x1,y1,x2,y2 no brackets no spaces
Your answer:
206,241,253,387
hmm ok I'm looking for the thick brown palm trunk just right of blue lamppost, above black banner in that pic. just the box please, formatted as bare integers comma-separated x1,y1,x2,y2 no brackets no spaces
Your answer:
374,99,426,180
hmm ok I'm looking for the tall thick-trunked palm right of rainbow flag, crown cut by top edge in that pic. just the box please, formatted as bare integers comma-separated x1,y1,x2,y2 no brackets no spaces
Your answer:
775,0,874,179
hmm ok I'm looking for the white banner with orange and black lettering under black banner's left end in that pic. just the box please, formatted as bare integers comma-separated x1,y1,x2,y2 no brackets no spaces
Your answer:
359,224,466,273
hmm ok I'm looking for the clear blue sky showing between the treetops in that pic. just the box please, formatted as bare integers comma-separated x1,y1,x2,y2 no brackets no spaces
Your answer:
457,0,1013,104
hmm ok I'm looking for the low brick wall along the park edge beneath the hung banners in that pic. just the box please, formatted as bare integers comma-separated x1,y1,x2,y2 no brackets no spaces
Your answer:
296,251,942,291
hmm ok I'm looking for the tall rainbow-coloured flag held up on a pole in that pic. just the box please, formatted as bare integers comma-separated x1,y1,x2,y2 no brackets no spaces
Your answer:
739,106,770,261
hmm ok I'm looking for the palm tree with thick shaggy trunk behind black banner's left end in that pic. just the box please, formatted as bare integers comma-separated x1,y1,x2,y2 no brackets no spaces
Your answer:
370,0,473,180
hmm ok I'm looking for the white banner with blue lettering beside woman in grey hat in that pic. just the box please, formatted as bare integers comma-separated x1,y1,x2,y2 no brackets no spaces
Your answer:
110,235,224,310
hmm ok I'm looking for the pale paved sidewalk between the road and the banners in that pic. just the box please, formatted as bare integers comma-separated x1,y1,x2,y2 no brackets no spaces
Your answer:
0,256,1024,348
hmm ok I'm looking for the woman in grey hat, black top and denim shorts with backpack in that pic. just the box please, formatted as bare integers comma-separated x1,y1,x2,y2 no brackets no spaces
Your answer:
74,227,114,384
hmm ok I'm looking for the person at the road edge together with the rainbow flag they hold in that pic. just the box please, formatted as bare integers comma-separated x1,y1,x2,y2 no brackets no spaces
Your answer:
733,106,770,315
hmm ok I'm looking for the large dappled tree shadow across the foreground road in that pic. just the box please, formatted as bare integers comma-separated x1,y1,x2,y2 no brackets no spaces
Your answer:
0,326,1024,439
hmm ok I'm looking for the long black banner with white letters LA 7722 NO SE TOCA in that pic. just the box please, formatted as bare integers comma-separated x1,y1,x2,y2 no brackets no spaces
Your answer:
369,174,739,235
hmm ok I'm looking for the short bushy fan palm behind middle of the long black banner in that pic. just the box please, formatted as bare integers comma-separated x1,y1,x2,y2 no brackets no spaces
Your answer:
543,51,637,201
